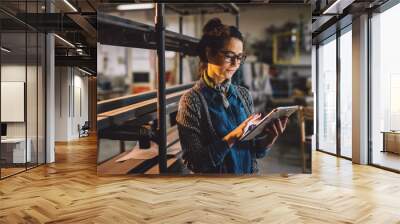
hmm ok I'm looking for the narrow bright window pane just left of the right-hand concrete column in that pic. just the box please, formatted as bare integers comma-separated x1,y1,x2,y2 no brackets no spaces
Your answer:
340,30,352,158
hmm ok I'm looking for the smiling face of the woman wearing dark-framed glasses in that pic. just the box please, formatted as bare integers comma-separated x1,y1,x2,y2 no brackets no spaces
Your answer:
207,38,243,83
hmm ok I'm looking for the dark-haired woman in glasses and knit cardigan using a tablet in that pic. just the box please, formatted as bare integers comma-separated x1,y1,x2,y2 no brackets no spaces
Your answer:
177,18,287,174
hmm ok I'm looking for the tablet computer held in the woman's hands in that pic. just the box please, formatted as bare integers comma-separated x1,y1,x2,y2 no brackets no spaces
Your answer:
239,106,299,141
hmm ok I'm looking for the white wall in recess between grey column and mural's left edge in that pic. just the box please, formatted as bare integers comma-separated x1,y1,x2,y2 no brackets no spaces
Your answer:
55,67,89,141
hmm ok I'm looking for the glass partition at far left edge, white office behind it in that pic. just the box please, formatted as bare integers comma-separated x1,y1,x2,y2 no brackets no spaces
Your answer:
0,32,27,178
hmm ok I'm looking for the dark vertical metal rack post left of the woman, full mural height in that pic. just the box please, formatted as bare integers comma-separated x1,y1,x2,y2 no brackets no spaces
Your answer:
156,3,167,174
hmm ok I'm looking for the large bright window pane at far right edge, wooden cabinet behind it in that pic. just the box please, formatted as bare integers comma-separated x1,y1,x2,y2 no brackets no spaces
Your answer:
371,4,400,170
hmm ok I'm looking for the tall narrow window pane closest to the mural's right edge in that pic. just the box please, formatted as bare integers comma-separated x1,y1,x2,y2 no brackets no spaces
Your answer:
317,37,336,153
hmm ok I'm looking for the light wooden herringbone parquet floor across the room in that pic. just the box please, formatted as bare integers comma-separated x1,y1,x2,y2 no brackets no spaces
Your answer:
0,137,400,224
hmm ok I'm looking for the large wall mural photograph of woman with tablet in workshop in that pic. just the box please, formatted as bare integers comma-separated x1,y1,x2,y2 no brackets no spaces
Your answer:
97,3,314,175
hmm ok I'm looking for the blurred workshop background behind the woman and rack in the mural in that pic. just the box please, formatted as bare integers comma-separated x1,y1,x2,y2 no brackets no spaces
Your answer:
97,2,314,173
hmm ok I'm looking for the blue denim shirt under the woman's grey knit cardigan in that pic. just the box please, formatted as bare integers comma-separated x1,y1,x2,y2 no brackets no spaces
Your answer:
200,80,255,174
